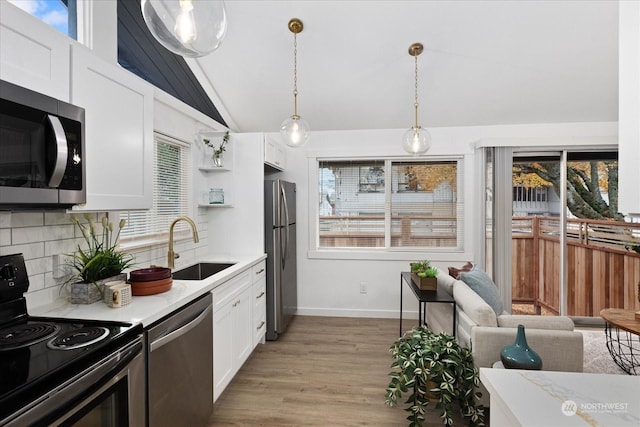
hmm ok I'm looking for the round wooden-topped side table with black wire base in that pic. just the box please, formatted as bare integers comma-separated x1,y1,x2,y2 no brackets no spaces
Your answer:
600,308,640,375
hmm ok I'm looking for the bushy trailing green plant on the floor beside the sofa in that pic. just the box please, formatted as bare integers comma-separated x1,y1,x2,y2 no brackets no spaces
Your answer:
385,326,485,427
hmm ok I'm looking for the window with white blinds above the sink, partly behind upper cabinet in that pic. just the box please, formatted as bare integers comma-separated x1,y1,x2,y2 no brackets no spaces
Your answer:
120,133,191,244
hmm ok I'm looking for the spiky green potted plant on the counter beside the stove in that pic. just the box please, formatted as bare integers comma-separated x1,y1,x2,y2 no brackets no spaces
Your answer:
66,214,134,304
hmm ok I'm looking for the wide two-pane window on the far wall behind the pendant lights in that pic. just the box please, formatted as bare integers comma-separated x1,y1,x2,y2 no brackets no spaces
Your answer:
317,159,464,249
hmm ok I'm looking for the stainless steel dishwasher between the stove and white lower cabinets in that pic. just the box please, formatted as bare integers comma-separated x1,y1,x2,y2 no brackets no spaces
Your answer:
147,293,213,427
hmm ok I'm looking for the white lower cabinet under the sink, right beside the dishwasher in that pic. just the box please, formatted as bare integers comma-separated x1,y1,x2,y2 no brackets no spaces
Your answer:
212,268,254,401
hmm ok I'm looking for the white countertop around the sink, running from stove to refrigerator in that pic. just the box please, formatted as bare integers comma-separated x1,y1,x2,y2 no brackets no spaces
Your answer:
29,254,267,327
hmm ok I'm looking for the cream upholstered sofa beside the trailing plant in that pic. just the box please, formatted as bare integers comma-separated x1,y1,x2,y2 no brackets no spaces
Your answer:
426,270,583,406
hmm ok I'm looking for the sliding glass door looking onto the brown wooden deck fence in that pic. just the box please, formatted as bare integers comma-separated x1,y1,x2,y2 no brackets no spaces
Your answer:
484,148,640,319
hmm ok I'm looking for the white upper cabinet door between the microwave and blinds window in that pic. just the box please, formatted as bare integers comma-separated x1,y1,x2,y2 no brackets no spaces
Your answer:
71,46,153,211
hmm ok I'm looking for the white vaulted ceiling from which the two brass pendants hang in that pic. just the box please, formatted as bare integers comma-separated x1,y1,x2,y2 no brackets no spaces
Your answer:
188,0,618,132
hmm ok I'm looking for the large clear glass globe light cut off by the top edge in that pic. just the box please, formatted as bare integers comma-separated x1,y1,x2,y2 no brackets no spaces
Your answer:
140,0,227,58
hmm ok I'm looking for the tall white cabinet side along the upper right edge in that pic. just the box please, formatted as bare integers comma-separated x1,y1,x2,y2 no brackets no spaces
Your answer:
618,1,640,215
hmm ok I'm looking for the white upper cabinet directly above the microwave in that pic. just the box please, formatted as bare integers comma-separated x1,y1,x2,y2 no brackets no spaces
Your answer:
0,1,71,102
